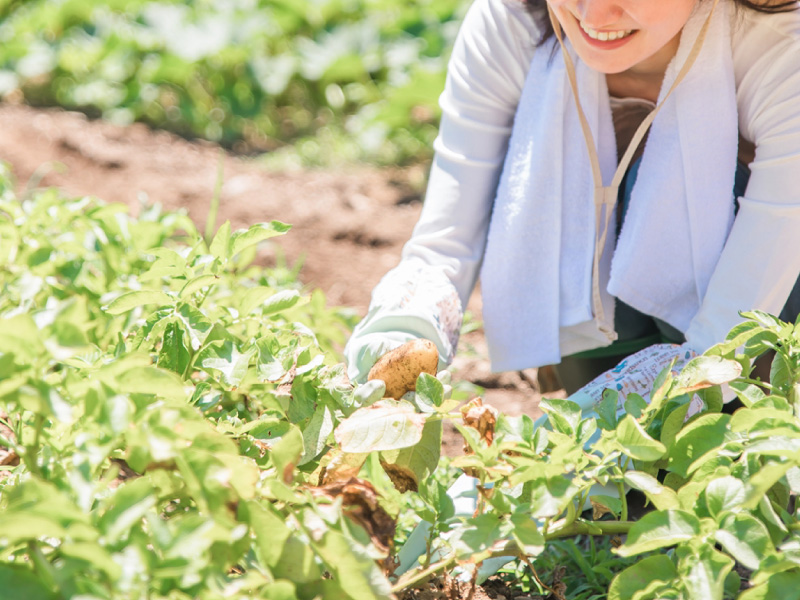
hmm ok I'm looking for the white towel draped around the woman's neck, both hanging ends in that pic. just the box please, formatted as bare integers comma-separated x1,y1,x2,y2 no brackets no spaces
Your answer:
481,0,738,371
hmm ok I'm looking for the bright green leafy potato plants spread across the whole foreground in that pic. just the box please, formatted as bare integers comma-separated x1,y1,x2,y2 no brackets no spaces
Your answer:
0,164,800,600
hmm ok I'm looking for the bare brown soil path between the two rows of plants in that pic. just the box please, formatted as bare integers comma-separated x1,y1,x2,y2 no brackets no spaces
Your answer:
0,104,562,454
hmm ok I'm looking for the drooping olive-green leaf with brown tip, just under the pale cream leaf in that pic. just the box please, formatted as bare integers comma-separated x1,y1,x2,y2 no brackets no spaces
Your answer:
380,420,442,492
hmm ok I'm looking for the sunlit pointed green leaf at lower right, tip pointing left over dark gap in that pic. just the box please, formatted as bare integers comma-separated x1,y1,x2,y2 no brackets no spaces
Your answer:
617,510,700,556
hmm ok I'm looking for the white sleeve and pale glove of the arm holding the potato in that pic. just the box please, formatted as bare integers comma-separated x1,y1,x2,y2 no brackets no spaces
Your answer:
345,0,538,379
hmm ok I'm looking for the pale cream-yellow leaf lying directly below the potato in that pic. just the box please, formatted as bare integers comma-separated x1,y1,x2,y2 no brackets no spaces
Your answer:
334,400,426,453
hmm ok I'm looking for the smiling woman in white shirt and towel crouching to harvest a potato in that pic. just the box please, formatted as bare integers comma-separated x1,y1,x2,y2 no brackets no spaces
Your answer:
346,0,800,404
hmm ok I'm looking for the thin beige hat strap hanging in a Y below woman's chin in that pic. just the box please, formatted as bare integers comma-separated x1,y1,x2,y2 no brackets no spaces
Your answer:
547,0,719,342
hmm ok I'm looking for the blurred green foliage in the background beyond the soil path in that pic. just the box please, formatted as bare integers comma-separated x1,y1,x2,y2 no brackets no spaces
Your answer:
0,0,467,163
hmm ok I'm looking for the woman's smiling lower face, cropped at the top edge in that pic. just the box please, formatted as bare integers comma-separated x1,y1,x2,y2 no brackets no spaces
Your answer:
547,0,697,74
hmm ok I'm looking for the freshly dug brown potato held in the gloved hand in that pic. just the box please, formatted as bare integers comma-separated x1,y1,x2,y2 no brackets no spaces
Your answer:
367,339,439,399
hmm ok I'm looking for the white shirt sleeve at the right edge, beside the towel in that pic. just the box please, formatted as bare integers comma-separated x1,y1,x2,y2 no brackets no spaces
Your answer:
686,12,800,352
